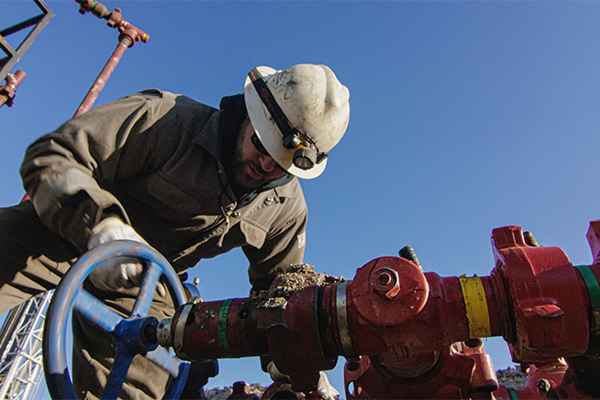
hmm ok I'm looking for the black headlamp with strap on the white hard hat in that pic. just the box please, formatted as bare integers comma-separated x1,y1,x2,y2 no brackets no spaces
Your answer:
248,68,327,170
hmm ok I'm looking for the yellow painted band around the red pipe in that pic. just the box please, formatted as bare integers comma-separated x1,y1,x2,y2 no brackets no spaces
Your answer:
458,275,492,339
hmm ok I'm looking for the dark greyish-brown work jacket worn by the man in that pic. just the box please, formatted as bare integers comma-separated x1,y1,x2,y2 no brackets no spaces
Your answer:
21,89,307,286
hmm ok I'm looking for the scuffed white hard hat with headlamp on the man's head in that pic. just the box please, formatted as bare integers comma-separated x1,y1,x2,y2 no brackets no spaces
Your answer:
244,64,350,179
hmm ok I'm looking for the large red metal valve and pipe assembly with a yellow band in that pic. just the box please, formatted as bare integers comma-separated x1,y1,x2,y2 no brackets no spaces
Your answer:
165,226,600,398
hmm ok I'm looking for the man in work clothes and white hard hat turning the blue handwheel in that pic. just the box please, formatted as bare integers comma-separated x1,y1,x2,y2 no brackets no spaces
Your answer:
0,64,349,398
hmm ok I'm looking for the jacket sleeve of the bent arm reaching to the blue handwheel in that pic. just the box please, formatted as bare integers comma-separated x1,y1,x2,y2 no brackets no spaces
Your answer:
20,91,174,251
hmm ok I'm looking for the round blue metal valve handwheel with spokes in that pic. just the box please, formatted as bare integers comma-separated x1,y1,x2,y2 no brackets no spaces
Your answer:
43,240,189,399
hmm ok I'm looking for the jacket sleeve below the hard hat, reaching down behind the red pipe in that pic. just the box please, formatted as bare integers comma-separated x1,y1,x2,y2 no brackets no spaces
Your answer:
243,205,307,291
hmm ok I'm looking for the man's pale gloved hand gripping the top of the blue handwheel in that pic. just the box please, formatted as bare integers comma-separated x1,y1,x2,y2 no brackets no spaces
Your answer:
88,217,166,297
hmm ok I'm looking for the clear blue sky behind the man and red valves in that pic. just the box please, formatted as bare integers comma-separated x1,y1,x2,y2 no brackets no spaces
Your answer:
0,0,600,391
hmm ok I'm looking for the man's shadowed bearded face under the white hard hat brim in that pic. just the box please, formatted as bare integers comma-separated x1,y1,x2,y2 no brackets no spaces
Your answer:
233,118,287,189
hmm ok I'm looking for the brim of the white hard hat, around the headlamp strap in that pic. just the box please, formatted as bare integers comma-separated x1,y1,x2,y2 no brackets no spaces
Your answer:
244,67,327,179
